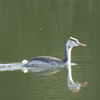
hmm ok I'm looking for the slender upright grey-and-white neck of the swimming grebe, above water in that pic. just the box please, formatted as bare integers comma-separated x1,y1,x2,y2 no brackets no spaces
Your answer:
63,44,72,65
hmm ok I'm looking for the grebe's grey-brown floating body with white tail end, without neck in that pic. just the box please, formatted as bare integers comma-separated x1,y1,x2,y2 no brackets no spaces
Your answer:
22,56,64,67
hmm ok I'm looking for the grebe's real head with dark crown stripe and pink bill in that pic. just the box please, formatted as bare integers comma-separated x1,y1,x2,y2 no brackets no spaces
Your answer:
67,37,86,48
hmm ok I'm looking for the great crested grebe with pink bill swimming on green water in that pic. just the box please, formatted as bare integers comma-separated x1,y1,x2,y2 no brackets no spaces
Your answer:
21,37,86,67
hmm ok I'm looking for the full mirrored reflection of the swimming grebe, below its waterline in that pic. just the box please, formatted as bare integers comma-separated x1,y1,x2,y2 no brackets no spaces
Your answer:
22,64,88,92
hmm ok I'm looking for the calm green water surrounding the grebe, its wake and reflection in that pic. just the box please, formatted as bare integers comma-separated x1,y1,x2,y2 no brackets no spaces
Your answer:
0,0,100,100
